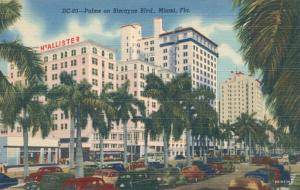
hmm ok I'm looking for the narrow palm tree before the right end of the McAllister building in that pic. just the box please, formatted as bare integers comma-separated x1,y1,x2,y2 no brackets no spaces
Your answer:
90,83,115,165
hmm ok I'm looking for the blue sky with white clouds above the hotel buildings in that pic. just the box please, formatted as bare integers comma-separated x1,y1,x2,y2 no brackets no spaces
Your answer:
0,0,247,82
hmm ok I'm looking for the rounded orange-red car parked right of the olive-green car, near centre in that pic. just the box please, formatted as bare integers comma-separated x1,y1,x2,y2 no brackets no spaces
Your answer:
181,165,205,182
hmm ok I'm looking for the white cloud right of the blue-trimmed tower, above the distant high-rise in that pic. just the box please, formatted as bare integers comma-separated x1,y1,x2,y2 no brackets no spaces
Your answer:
218,43,244,65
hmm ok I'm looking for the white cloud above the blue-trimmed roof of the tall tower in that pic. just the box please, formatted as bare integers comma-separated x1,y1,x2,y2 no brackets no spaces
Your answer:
178,16,233,37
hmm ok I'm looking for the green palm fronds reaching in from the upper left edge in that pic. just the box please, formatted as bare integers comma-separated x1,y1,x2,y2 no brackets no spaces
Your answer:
0,0,44,101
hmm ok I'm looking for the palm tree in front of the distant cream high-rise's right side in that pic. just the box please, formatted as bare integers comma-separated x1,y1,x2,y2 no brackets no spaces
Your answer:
234,113,258,158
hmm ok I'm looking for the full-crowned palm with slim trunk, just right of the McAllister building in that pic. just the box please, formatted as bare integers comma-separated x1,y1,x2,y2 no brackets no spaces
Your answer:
111,81,145,166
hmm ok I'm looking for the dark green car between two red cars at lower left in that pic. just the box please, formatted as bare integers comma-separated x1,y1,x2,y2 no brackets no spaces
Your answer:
25,172,74,190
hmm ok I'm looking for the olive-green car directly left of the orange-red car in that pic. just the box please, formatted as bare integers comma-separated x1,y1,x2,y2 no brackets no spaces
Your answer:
149,168,187,186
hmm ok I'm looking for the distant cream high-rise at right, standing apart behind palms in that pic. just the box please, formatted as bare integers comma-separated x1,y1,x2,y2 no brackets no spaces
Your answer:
220,72,267,123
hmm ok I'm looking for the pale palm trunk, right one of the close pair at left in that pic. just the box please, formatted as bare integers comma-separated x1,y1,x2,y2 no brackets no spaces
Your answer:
76,125,84,178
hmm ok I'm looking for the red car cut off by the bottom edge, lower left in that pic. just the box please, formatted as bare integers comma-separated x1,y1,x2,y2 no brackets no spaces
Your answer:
61,177,117,190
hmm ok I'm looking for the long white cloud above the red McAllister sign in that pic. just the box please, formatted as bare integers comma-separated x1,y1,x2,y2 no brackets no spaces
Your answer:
10,1,119,46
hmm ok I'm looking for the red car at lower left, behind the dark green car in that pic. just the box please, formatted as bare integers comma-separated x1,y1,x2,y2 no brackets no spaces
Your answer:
24,166,63,183
